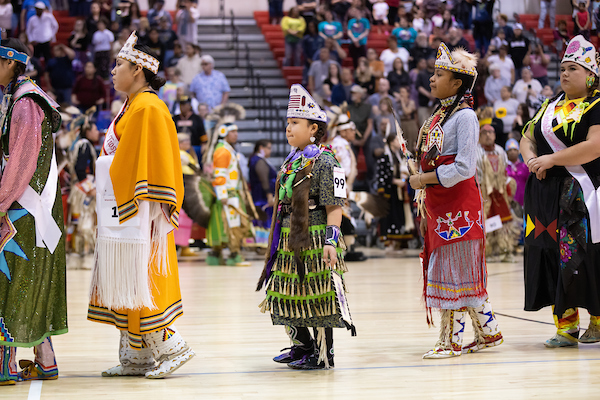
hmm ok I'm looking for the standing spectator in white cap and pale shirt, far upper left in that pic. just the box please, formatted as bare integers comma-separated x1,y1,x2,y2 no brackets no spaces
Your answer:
27,1,58,61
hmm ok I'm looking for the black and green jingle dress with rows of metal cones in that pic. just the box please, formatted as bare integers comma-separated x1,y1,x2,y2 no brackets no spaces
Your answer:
260,145,349,328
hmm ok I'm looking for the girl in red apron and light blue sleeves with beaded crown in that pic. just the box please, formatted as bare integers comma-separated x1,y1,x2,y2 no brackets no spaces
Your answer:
410,43,502,358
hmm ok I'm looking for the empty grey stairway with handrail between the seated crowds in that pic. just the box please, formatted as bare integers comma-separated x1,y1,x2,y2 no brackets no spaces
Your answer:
198,18,289,165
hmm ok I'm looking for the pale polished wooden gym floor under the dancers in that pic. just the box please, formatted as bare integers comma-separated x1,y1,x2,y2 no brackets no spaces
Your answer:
0,252,600,400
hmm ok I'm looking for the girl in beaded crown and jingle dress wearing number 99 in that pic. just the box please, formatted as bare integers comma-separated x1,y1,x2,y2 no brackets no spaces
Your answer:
257,85,355,369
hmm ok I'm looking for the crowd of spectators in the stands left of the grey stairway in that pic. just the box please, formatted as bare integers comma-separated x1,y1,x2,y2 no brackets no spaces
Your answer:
0,0,230,153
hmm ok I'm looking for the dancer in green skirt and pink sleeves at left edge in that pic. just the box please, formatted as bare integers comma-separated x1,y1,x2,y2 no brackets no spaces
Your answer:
0,39,67,385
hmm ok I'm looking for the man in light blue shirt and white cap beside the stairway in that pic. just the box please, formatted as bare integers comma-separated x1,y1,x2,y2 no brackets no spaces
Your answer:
190,55,231,110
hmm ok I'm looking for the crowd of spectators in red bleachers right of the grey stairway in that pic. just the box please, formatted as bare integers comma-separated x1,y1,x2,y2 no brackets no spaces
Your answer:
269,0,600,193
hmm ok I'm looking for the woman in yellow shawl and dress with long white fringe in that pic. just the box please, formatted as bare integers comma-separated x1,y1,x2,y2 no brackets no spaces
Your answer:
88,32,194,378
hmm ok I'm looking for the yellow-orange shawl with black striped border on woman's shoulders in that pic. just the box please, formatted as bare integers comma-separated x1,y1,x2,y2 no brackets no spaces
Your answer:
110,92,184,227
